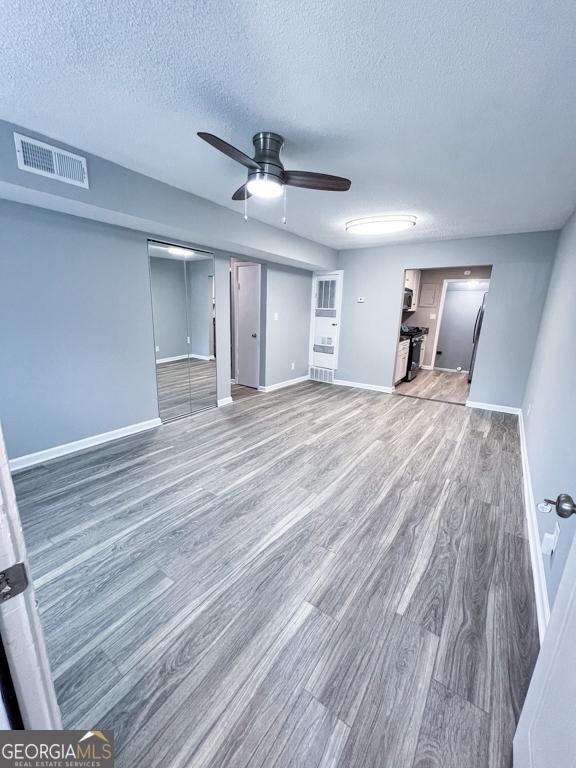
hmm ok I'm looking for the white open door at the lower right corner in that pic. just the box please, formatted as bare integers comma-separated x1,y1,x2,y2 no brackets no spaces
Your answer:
514,520,576,768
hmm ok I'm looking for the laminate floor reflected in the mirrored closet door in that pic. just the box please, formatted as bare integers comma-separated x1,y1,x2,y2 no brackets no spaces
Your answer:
156,358,216,421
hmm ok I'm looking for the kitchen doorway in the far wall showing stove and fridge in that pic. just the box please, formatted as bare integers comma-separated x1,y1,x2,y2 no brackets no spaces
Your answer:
394,266,492,405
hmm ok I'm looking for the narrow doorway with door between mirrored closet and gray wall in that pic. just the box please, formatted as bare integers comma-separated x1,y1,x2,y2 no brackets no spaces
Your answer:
230,259,262,400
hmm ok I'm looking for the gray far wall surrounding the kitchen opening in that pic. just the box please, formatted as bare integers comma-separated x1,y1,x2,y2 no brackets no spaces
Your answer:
337,232,558,407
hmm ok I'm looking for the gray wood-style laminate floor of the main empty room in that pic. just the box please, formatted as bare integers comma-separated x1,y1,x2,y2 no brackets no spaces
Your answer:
15,382,538,768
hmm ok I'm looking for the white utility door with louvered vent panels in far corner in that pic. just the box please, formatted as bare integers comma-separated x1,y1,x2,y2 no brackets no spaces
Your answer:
310,272,342,371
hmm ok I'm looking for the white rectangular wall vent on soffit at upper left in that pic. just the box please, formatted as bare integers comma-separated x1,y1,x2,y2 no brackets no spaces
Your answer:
14,133,90,189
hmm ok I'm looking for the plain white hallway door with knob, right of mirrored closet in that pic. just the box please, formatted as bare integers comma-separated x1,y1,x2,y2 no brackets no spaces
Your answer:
236,264,260,389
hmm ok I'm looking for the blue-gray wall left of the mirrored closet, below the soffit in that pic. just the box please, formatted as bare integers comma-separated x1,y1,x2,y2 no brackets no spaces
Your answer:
0,202,158,458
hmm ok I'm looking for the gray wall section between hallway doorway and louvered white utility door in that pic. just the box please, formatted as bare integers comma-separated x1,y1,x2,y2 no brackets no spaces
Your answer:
265,264,312,387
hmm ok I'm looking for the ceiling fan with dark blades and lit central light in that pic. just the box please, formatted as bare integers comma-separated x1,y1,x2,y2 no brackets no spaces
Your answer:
198,131,351,200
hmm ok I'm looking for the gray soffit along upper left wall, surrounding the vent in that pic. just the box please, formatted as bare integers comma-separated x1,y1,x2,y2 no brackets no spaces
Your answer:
0,120,336,269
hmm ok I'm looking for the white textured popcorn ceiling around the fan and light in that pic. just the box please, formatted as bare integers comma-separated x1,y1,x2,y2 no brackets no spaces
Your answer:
0,0,576,248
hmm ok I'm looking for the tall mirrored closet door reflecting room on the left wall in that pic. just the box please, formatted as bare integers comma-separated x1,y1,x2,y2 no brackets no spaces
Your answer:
148,241,216,421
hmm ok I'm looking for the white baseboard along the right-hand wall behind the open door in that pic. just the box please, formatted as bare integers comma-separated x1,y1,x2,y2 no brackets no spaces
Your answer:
518,411,550,645
